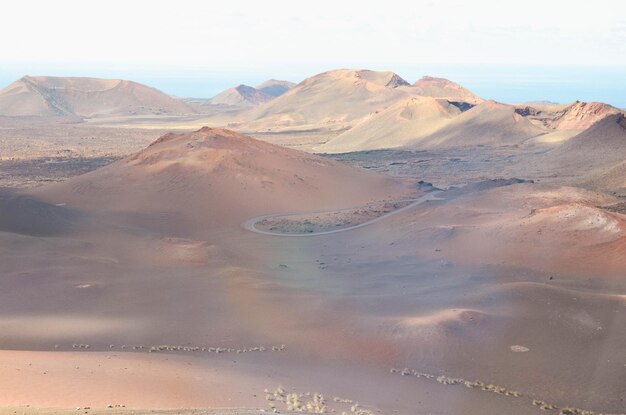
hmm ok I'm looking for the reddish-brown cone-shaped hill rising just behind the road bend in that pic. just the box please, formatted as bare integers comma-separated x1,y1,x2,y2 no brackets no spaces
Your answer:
34,127,409,236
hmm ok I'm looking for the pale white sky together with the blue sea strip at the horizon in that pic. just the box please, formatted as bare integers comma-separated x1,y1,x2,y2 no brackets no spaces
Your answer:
0,0,626,107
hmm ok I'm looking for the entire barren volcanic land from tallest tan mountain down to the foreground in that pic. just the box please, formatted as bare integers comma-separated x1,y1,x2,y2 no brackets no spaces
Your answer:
0,70,626,415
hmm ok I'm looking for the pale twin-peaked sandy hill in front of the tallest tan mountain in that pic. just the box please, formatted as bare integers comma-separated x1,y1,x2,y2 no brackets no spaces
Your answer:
315,97,545,153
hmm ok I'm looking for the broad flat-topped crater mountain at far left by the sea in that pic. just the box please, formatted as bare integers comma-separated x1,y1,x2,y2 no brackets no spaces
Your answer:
0,76,195,118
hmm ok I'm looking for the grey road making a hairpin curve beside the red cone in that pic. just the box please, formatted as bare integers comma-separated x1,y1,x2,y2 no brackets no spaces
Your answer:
243,191,443,237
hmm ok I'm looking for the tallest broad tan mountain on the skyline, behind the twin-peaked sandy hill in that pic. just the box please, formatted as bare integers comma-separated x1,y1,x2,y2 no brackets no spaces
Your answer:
222,69,490,135
